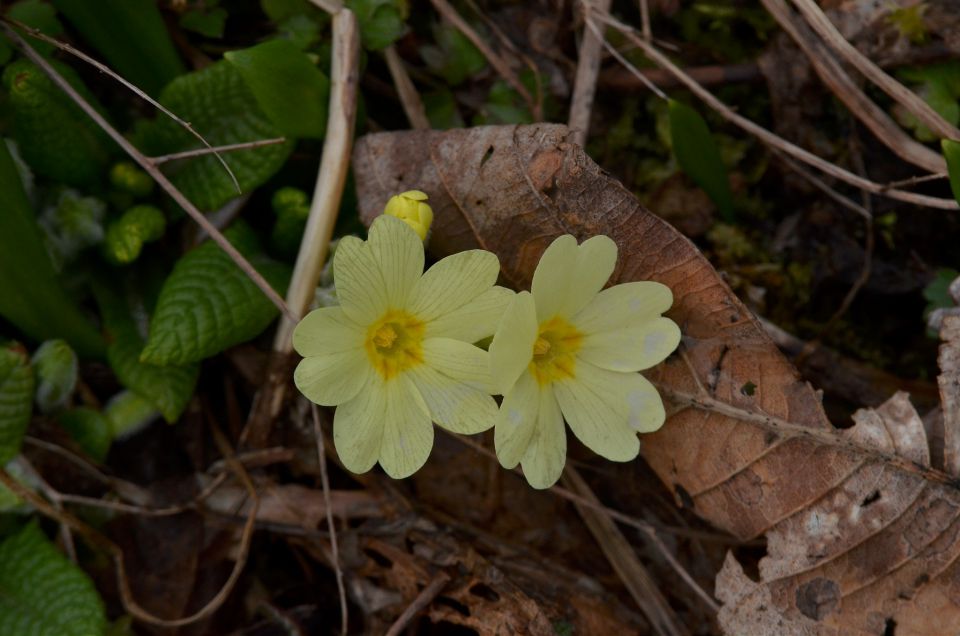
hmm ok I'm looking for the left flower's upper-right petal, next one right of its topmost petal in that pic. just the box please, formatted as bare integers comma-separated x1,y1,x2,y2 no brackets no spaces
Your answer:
407,250,500,320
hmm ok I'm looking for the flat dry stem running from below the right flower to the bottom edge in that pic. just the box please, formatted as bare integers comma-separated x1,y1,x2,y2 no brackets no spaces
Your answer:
561,464,686,636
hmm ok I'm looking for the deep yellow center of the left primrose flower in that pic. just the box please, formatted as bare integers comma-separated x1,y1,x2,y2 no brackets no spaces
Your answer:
364,309,424,380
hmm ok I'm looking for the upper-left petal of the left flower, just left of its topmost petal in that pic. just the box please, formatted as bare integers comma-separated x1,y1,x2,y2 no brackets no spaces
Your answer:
333,236,389,325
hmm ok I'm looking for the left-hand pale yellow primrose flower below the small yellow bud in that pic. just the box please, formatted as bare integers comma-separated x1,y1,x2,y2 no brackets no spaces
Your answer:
293,216,514,479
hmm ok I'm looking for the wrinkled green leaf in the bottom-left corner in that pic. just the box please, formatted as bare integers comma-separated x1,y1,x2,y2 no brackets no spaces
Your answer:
0,523,107,636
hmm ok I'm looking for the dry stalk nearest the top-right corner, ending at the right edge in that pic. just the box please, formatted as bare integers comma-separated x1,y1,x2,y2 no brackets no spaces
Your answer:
793,0,960,139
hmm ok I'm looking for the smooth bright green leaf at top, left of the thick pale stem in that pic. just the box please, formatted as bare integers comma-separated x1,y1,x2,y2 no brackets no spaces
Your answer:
224,40,330,139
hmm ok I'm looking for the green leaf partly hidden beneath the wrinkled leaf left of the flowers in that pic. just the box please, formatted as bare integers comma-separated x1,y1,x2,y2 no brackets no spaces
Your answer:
95,285,200,423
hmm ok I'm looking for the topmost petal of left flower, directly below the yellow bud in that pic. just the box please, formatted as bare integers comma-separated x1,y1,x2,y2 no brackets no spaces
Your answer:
367,215,423,308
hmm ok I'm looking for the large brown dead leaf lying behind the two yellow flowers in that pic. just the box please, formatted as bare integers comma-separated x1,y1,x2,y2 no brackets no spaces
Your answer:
354,125,960,635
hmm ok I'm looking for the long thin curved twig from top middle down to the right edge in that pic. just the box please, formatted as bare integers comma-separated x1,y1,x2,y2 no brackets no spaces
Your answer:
597,9,960,210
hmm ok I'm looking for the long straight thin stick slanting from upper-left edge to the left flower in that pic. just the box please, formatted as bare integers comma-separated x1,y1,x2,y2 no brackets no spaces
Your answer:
0,22,290,315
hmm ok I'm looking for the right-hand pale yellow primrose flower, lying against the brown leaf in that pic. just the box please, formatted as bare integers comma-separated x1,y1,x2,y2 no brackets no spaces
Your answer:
490,234,680,488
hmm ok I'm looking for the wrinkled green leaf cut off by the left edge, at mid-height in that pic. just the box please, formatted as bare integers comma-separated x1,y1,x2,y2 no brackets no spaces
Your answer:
0,345,34,464
